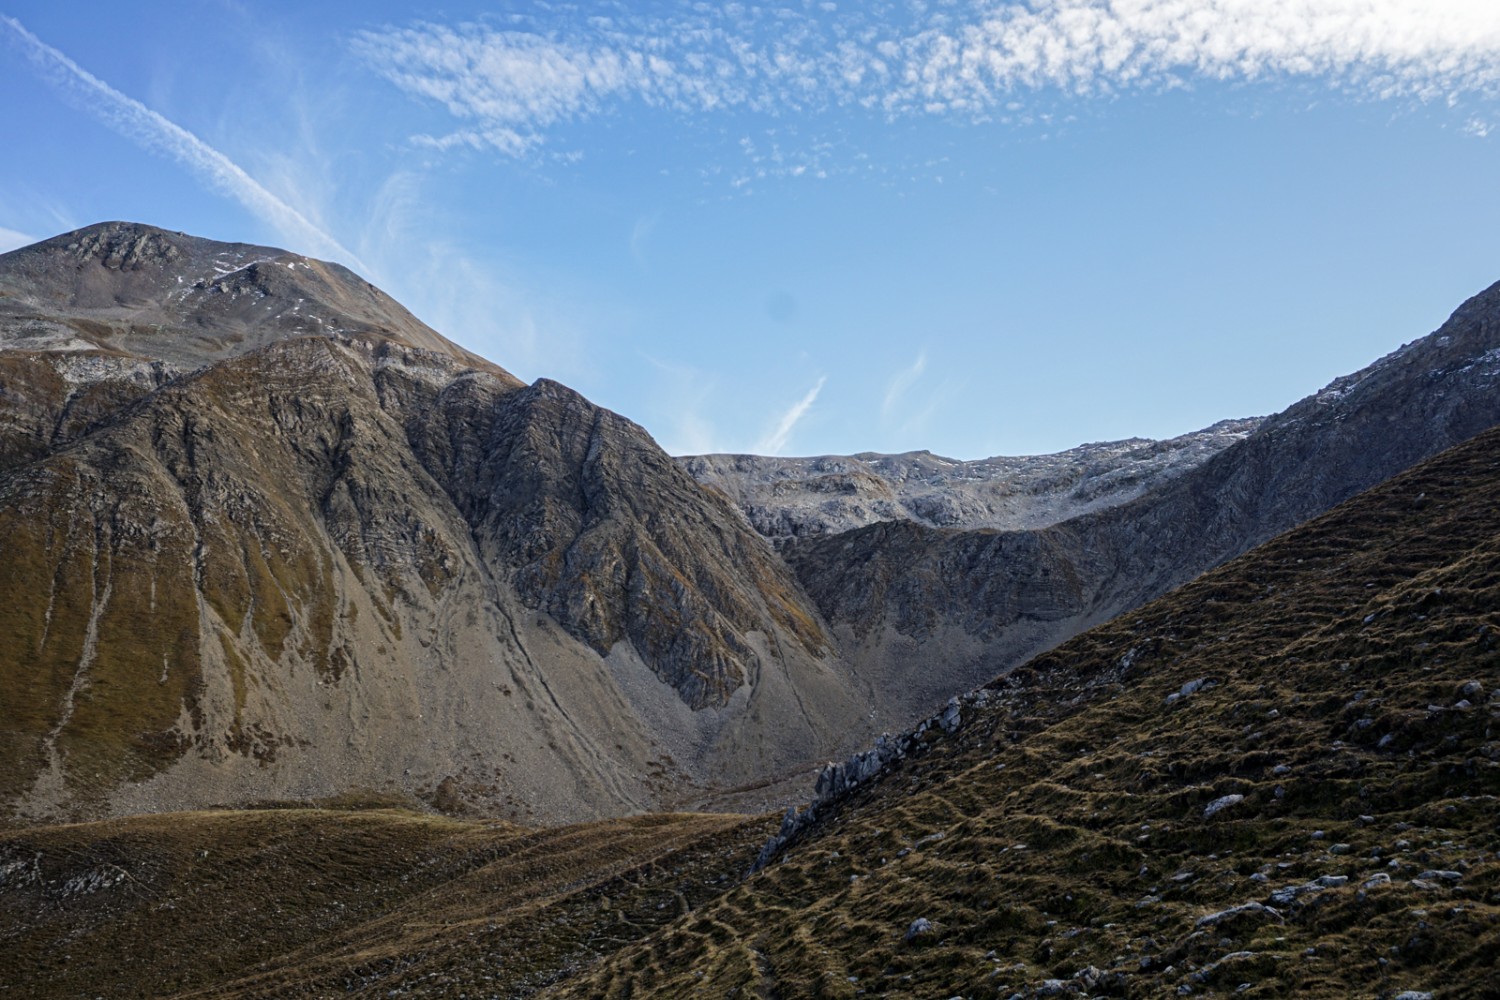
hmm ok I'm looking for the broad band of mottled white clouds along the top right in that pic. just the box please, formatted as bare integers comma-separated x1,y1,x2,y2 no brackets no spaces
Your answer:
354,0,1500,156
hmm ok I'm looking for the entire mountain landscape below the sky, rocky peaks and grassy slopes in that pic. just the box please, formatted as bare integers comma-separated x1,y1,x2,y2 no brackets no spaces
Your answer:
0,223,1500,997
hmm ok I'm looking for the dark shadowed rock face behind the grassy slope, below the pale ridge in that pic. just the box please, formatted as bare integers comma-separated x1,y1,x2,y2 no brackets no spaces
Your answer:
785,277,1500,701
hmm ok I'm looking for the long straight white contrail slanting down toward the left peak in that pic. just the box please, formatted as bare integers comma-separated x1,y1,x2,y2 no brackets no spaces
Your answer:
0,15,366,270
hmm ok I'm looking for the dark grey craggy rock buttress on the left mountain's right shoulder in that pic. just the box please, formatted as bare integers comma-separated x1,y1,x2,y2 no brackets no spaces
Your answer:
393,379,830,709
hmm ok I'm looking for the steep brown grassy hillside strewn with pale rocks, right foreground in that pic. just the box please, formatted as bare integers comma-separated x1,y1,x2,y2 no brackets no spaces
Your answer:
558,432,1500,997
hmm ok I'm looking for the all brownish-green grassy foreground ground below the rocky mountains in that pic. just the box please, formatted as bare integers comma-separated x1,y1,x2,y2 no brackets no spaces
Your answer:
0,419,1500,999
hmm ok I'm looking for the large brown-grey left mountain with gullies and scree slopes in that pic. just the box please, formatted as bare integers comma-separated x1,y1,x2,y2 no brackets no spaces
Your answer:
0,226,864,819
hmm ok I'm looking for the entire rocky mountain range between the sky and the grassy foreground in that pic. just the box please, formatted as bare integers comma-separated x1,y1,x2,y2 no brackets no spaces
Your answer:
0,223,1500,820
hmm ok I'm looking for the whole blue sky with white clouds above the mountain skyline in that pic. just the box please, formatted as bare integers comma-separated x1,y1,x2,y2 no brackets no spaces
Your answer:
0,0,1500,457
